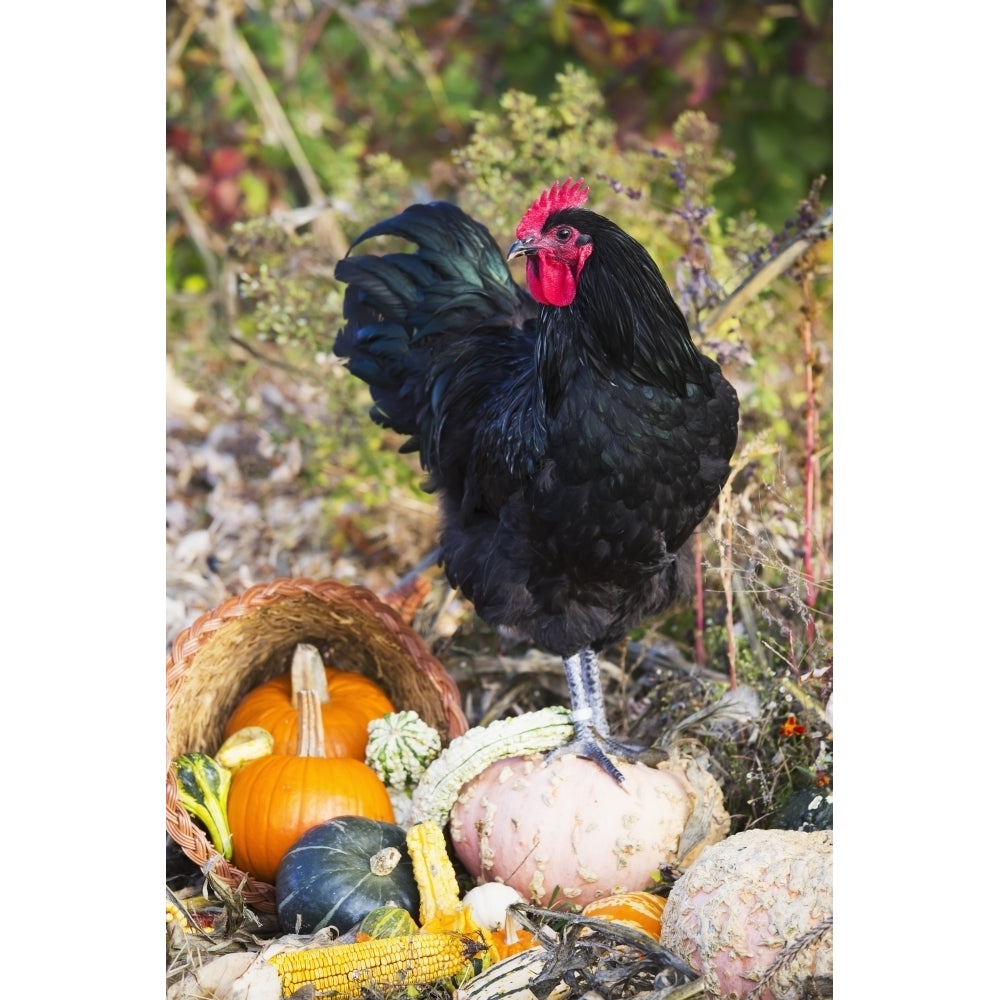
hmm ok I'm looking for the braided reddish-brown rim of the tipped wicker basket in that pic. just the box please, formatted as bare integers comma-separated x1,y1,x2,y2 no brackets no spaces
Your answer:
165,577,468,912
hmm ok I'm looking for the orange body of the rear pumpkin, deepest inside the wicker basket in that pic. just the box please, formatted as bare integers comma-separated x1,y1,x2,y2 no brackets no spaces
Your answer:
225,653,395,760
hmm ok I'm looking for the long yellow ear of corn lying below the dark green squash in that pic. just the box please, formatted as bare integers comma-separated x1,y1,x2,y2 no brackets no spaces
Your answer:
268,934,485,998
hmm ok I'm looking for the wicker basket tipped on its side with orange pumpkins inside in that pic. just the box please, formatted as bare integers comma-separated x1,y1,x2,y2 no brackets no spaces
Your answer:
167,579,468,912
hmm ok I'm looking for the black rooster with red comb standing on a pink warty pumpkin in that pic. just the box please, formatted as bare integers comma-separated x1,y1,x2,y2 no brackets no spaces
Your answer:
334,181,739,781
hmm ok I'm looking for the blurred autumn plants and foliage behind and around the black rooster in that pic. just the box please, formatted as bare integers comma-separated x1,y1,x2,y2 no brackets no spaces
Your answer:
166,0,833,821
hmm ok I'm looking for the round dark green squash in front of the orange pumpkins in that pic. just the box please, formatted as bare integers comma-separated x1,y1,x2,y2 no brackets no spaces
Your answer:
275,816,420,934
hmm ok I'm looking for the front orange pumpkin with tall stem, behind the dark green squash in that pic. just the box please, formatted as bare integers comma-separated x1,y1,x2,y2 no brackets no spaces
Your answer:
229,662,395,883
